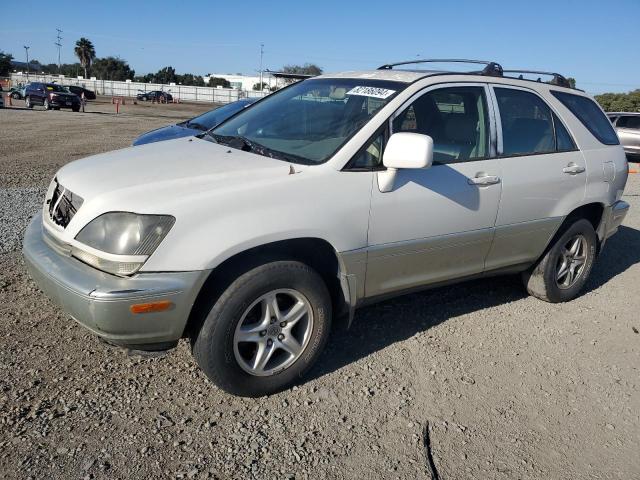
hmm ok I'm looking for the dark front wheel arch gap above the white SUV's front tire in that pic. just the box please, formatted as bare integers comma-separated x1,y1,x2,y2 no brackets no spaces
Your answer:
183,237,355,337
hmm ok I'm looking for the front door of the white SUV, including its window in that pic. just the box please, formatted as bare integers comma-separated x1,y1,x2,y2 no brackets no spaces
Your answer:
365,84,502,297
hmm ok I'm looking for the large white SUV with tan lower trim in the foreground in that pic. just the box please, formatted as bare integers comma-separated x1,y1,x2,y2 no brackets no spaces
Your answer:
23,60,629,396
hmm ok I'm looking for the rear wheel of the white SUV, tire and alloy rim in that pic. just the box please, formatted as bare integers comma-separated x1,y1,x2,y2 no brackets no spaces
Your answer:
522,219,597,303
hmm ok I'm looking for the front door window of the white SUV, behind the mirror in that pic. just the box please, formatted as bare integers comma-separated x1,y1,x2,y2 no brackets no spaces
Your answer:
393,87,489,164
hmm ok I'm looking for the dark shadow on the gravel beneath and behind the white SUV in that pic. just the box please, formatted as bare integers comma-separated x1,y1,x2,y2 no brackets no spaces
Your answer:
309,226,640,379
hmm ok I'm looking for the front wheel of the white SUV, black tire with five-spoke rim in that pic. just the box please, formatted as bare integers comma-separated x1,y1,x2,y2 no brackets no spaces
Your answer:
191,260,331,397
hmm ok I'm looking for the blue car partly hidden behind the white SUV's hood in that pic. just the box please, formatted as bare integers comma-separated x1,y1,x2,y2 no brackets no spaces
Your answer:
133,98,258,146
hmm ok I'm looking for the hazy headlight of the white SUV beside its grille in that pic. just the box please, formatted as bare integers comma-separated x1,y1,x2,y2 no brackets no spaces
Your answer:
72,212,175,275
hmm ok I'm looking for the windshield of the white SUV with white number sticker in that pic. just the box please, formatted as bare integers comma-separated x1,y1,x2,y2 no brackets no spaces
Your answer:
211,78,406,164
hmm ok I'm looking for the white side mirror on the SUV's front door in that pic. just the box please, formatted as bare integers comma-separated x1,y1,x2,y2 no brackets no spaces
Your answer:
378,132,433,192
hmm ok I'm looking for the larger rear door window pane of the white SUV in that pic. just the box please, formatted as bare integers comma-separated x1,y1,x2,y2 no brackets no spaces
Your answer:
494,87,556,156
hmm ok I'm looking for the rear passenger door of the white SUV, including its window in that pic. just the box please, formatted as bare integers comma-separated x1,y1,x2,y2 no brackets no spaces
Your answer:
486,85,587,270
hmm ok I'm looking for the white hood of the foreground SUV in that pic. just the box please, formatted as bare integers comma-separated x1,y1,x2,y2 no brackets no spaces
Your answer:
56,137,306,234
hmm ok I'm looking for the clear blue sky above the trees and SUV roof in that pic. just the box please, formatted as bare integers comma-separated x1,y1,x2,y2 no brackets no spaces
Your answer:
0,0,640,93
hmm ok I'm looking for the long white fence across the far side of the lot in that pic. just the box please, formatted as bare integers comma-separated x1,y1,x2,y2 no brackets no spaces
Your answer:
11,73,267,103
